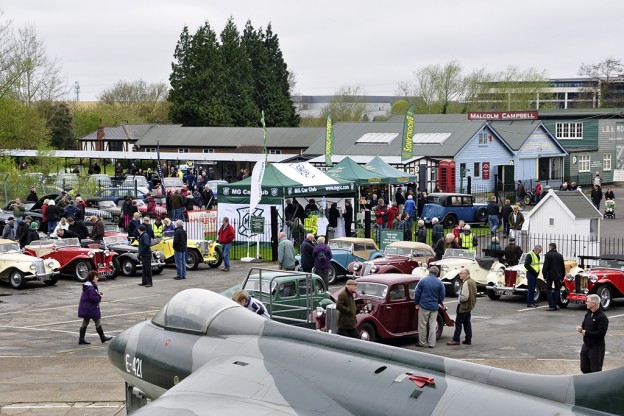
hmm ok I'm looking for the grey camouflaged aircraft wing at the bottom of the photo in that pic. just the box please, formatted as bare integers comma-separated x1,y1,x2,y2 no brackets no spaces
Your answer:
132,356,352,416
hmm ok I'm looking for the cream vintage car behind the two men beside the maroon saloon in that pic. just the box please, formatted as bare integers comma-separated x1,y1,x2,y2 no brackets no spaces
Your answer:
412,248,504,296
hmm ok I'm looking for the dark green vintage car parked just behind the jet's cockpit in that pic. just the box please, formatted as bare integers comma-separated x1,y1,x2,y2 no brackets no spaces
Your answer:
221,268,333,328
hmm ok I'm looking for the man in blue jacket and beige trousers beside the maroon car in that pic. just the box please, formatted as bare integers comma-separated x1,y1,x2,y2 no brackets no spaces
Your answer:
414,266,446,348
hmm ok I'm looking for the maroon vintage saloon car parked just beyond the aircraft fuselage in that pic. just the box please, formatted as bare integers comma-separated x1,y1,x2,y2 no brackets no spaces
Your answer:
325,274,455,341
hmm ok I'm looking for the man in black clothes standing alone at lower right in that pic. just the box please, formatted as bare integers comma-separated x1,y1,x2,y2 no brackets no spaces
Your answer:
576,294,609,374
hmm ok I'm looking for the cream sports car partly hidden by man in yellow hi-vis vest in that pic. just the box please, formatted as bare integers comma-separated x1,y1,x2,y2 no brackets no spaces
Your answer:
486,253,577,303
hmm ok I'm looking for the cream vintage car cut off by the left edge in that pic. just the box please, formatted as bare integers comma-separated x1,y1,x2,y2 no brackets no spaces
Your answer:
0,239,61,289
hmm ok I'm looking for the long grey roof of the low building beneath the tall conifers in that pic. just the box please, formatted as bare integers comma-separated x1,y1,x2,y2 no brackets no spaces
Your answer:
137,126,325,149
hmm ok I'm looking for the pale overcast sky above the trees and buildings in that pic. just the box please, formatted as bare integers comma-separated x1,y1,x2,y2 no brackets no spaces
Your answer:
0,0,624,101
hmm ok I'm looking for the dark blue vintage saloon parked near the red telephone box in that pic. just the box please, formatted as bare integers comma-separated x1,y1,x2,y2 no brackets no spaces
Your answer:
421,193,487,228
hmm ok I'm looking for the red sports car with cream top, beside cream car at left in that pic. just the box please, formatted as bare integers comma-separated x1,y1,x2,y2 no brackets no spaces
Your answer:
24,238,119,282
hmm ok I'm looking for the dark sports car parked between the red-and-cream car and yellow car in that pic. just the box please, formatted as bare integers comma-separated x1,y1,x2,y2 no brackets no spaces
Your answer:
89,234,165,276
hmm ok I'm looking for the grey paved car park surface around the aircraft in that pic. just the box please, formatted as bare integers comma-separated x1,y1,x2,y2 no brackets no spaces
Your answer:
0,261,624,416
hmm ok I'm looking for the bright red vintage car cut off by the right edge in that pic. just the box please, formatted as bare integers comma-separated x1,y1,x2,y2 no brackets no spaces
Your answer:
559,254,624,311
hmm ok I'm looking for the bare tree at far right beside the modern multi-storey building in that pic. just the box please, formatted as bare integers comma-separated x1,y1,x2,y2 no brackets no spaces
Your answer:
578,57,624,107
